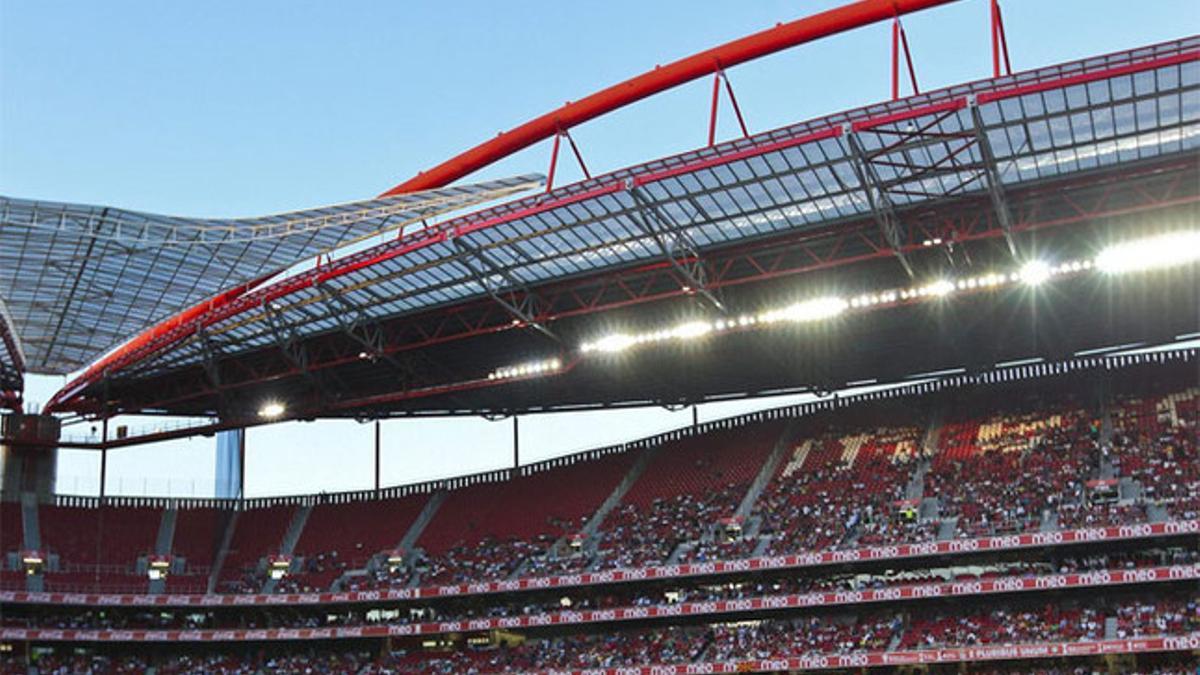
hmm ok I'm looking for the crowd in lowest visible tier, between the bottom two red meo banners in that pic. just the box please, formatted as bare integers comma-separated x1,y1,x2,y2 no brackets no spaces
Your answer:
4,591,1200,675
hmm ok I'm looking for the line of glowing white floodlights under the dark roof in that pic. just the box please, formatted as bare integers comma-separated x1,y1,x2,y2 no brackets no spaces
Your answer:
258,231,1200,419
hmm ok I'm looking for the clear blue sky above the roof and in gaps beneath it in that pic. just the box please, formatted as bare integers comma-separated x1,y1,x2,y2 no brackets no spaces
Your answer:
0,0,1200,494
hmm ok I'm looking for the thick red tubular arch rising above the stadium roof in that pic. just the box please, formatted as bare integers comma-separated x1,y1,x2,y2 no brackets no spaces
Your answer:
380,0,955,197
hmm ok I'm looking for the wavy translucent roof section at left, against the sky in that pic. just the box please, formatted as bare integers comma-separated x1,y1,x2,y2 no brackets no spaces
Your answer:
0,175,541,389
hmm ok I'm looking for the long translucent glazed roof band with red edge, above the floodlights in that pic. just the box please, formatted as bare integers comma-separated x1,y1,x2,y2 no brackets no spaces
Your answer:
58,37,1200,393
